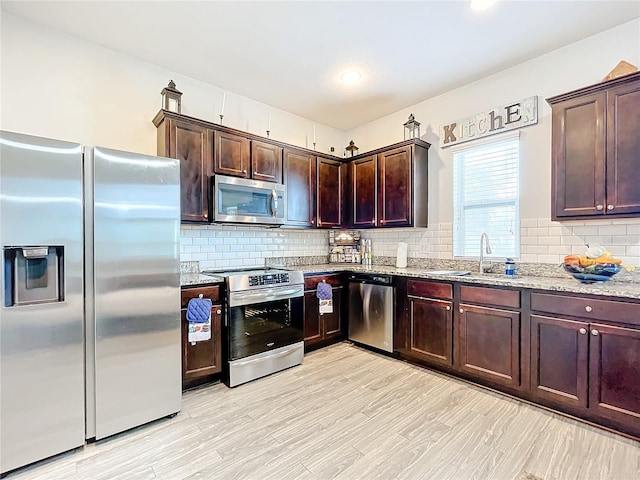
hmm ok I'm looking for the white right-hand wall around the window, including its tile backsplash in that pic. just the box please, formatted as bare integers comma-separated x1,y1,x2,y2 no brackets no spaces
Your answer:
347,19,640,266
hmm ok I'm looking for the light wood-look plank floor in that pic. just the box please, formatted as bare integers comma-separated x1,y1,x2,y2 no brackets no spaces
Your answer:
7,343,640,480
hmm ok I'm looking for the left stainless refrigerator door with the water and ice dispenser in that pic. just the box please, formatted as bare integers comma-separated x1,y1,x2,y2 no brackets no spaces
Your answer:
0,131,84,473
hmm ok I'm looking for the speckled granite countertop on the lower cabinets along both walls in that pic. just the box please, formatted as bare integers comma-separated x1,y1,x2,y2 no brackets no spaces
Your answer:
180,263,640,300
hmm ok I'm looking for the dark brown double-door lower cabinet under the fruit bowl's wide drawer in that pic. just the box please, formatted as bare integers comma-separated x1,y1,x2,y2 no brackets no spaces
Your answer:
531,315,640,434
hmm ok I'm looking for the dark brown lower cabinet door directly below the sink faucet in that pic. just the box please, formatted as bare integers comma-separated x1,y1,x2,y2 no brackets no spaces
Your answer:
457,304,520,387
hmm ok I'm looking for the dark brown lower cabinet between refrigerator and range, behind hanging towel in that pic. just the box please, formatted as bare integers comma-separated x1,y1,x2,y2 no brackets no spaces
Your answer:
180,286,222,388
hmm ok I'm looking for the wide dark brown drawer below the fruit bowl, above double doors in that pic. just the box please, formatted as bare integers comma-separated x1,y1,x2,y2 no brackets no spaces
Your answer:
531,293,640,325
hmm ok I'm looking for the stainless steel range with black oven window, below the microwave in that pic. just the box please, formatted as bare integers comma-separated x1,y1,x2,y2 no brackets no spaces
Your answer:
203,268,304,387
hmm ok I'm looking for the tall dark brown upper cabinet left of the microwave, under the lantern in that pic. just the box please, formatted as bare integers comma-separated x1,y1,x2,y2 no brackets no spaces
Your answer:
154,117,212,222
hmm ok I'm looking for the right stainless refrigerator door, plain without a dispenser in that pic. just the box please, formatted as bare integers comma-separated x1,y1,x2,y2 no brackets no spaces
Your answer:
85,147,182,439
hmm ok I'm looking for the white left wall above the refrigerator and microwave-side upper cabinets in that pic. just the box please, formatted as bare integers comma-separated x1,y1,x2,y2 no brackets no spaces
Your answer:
0,12,346,154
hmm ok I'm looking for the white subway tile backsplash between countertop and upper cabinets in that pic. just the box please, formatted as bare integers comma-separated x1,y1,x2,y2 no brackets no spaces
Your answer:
180,218,640,270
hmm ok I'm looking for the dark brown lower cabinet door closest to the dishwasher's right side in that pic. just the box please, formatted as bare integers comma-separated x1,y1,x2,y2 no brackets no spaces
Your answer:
409,296,453,366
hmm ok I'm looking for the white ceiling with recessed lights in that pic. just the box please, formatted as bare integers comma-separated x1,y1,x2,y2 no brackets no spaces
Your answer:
2,0,640,130
